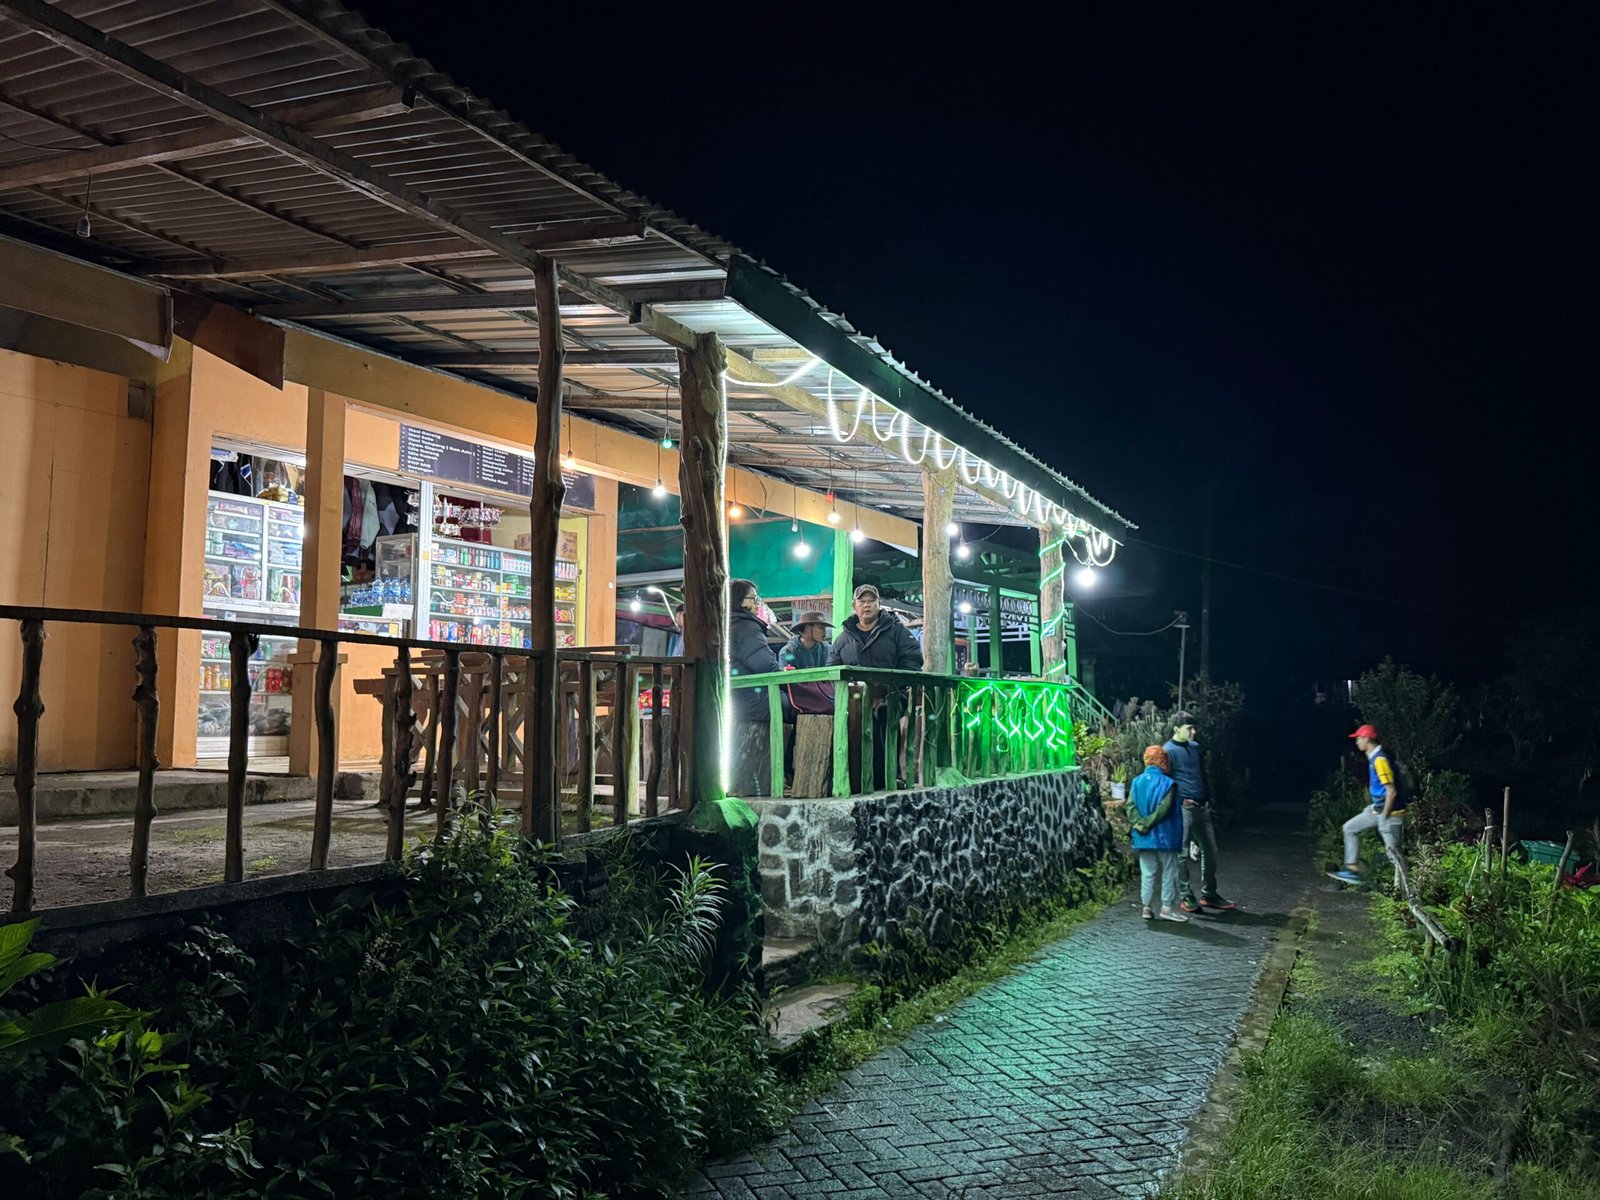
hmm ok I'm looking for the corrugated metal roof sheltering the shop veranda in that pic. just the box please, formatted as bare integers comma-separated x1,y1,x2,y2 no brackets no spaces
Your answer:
0,0,1126,533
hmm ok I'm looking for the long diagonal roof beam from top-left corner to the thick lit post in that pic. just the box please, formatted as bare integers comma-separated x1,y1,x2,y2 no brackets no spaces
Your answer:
0,0,635,317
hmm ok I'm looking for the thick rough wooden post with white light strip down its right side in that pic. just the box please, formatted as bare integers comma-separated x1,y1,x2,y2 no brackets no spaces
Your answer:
678,333,728,808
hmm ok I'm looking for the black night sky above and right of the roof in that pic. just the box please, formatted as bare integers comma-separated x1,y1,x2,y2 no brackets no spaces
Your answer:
357,0,1600,761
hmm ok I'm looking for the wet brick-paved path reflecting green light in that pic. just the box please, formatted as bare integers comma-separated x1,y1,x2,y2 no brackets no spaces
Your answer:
682,830,1309,1200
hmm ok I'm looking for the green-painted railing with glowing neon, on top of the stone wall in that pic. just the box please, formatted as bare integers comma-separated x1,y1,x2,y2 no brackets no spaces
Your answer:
730,667,1080,797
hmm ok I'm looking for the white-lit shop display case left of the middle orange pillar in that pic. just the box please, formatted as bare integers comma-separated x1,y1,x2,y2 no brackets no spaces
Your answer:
195,493,304,758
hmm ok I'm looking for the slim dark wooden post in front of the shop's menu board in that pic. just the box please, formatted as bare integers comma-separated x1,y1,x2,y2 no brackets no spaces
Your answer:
522,258,566,843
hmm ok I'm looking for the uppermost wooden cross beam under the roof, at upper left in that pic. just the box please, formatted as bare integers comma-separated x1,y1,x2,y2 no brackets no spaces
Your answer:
0,86,411,190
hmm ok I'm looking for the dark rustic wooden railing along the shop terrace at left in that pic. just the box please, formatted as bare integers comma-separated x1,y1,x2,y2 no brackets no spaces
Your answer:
0,605,694,912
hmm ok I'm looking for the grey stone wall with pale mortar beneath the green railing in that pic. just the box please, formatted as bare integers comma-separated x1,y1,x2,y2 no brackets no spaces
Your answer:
754,771,1107,952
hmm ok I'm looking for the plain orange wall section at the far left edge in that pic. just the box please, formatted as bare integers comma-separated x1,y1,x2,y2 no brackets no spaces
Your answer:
0,350,150,771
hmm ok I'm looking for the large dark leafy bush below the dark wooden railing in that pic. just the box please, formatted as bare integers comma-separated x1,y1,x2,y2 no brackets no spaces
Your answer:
1,827,781,1198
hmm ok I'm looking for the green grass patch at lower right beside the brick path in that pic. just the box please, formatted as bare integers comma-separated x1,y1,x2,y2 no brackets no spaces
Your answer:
1162,902,1600,1200
